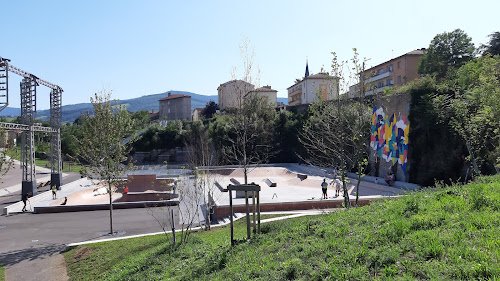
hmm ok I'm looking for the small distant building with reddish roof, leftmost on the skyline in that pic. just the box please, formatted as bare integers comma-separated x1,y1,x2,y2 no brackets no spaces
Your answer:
159,92,192,121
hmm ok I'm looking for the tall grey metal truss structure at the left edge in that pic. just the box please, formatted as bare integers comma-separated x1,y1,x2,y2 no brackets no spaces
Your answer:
0,57,63,195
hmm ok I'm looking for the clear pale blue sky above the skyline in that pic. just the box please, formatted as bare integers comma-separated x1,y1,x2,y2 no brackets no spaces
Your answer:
0,0,500,109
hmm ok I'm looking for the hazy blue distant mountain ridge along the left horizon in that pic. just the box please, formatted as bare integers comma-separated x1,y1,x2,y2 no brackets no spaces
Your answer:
0,91,288,122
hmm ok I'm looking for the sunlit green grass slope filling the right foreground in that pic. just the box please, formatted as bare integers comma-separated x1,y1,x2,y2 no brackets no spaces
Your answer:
65,176,500,280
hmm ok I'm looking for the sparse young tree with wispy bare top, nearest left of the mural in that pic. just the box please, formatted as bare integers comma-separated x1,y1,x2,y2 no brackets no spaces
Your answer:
299,49,371,207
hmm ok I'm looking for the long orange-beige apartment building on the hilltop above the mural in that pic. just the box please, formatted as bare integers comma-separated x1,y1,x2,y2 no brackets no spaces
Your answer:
348,48,425,98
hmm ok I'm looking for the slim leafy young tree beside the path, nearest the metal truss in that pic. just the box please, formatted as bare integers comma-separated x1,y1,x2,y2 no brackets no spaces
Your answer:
78,92,133,235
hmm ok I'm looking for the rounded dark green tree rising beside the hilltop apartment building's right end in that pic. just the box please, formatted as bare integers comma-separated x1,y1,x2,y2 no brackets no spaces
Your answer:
418,29,475,78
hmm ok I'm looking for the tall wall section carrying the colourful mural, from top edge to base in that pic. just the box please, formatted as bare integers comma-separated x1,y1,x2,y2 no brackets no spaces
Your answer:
370,94,410,181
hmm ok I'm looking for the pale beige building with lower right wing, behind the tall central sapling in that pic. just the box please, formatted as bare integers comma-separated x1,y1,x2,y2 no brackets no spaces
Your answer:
217,80,278,110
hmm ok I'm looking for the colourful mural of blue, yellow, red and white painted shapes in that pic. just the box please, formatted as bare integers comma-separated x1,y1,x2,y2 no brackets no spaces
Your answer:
370,106,410,175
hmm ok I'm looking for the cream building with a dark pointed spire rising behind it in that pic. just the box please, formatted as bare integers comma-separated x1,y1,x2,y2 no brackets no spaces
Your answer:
288,71,339,106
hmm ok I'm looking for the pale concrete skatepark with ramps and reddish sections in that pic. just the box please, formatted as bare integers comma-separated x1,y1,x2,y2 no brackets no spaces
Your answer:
3,164,415,219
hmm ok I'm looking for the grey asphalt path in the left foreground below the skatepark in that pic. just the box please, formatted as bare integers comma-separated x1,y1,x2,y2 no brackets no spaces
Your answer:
0,205,178,280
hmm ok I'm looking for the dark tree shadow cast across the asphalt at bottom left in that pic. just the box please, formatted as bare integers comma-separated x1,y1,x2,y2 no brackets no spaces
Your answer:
0,244,66,266
